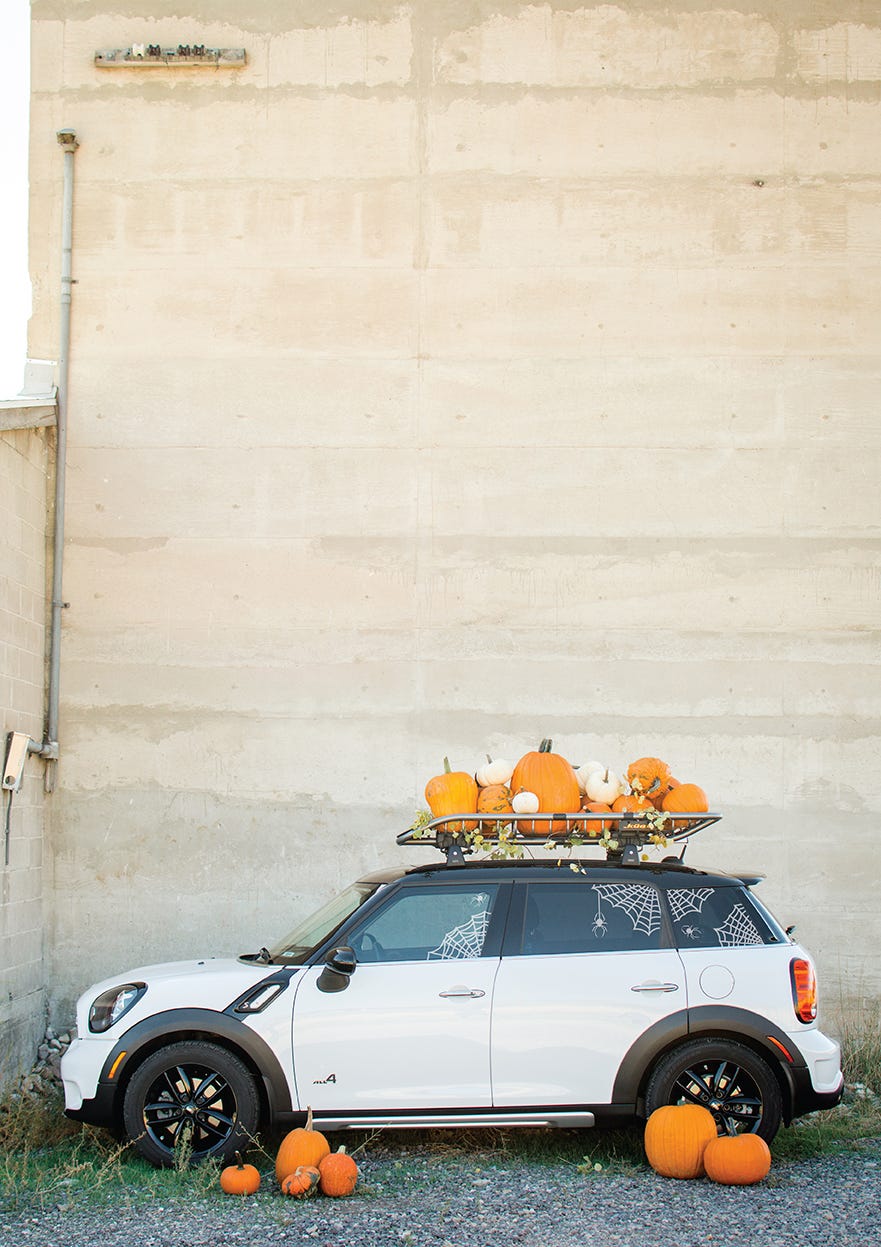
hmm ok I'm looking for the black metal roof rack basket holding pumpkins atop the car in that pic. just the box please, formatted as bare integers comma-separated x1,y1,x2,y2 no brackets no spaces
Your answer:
397,811,721,865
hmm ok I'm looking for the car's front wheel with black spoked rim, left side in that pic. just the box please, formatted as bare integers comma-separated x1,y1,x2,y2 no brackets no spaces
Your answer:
122,1040,260,1167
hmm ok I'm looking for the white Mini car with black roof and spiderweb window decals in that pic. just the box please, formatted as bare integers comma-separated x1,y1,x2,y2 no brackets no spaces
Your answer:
61,833,842,1165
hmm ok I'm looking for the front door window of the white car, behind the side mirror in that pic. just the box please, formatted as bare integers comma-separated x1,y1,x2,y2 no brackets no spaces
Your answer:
349,883,499,961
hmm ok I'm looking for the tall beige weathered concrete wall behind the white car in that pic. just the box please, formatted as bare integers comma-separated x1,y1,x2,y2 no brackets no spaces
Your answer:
30,0,881,1014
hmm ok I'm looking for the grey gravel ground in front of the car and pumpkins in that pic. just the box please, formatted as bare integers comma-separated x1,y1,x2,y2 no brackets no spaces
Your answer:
0,1140,881,1247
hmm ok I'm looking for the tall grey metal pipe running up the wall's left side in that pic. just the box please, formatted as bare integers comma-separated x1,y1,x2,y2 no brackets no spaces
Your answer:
35,130,80,792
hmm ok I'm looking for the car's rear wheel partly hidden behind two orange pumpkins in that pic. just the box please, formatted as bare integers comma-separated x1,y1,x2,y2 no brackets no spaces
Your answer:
645,1039,782,1143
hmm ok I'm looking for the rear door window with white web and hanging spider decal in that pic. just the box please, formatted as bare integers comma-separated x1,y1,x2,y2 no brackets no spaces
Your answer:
522,882,661,956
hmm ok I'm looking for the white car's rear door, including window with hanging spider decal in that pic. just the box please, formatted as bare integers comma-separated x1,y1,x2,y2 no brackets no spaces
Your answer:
492,879,686,1107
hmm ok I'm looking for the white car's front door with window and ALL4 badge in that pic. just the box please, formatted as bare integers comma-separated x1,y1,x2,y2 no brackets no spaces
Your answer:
293,880,509,1112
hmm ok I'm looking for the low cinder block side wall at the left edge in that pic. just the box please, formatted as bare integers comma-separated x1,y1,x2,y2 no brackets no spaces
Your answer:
0,429,47,1094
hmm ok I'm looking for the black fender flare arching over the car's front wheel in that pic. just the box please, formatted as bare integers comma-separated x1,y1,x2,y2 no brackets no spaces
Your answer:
99,1009,292,1120
